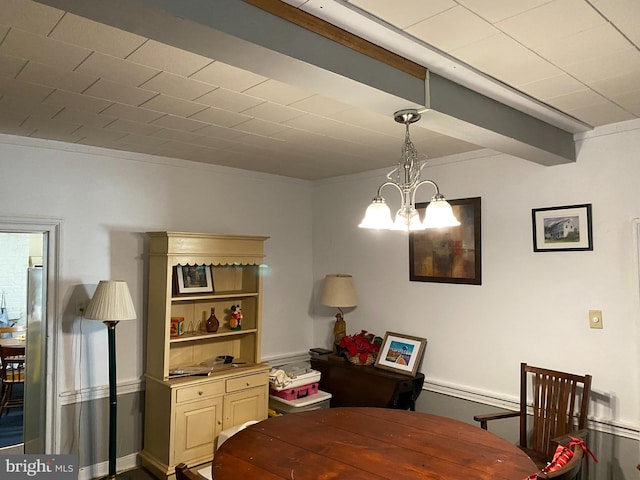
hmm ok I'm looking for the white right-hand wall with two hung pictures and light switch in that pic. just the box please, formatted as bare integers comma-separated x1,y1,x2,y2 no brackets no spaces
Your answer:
313,121,640,436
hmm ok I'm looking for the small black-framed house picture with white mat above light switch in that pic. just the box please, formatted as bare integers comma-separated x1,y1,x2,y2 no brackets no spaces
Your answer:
531,203,593,252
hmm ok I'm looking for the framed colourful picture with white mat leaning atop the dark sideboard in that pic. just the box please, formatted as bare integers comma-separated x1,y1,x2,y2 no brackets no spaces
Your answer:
374,332,427,377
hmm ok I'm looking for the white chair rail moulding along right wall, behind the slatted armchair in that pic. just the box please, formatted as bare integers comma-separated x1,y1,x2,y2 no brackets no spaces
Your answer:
422,379,640,441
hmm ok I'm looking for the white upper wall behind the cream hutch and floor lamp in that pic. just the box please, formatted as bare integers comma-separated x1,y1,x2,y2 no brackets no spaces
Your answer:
0,135,312,395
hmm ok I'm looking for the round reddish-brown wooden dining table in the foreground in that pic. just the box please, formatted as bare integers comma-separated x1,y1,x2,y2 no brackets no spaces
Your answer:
211,407,537,480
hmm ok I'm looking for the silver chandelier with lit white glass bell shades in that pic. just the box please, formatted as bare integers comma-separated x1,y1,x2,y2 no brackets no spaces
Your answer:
358,109,460,231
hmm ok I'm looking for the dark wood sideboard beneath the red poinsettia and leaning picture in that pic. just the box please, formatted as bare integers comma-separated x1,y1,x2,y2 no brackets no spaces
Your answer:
311,355,424,410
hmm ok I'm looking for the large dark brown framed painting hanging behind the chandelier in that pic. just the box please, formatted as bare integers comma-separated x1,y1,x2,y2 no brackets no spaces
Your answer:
409,197,482,285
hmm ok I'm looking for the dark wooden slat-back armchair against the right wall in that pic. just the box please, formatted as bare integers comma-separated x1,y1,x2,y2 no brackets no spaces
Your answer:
473,363,591,467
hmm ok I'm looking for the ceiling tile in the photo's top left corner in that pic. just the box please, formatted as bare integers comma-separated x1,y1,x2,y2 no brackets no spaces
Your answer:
0,0,64,35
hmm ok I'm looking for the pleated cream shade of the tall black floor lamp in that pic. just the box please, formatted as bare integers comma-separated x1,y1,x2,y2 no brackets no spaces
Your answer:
84,280,136,321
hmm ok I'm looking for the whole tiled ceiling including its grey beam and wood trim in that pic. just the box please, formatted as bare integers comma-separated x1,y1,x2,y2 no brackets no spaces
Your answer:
0,0,640,180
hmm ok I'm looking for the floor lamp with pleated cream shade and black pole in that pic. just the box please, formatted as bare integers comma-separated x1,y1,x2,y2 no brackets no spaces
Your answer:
84,280,136,480
